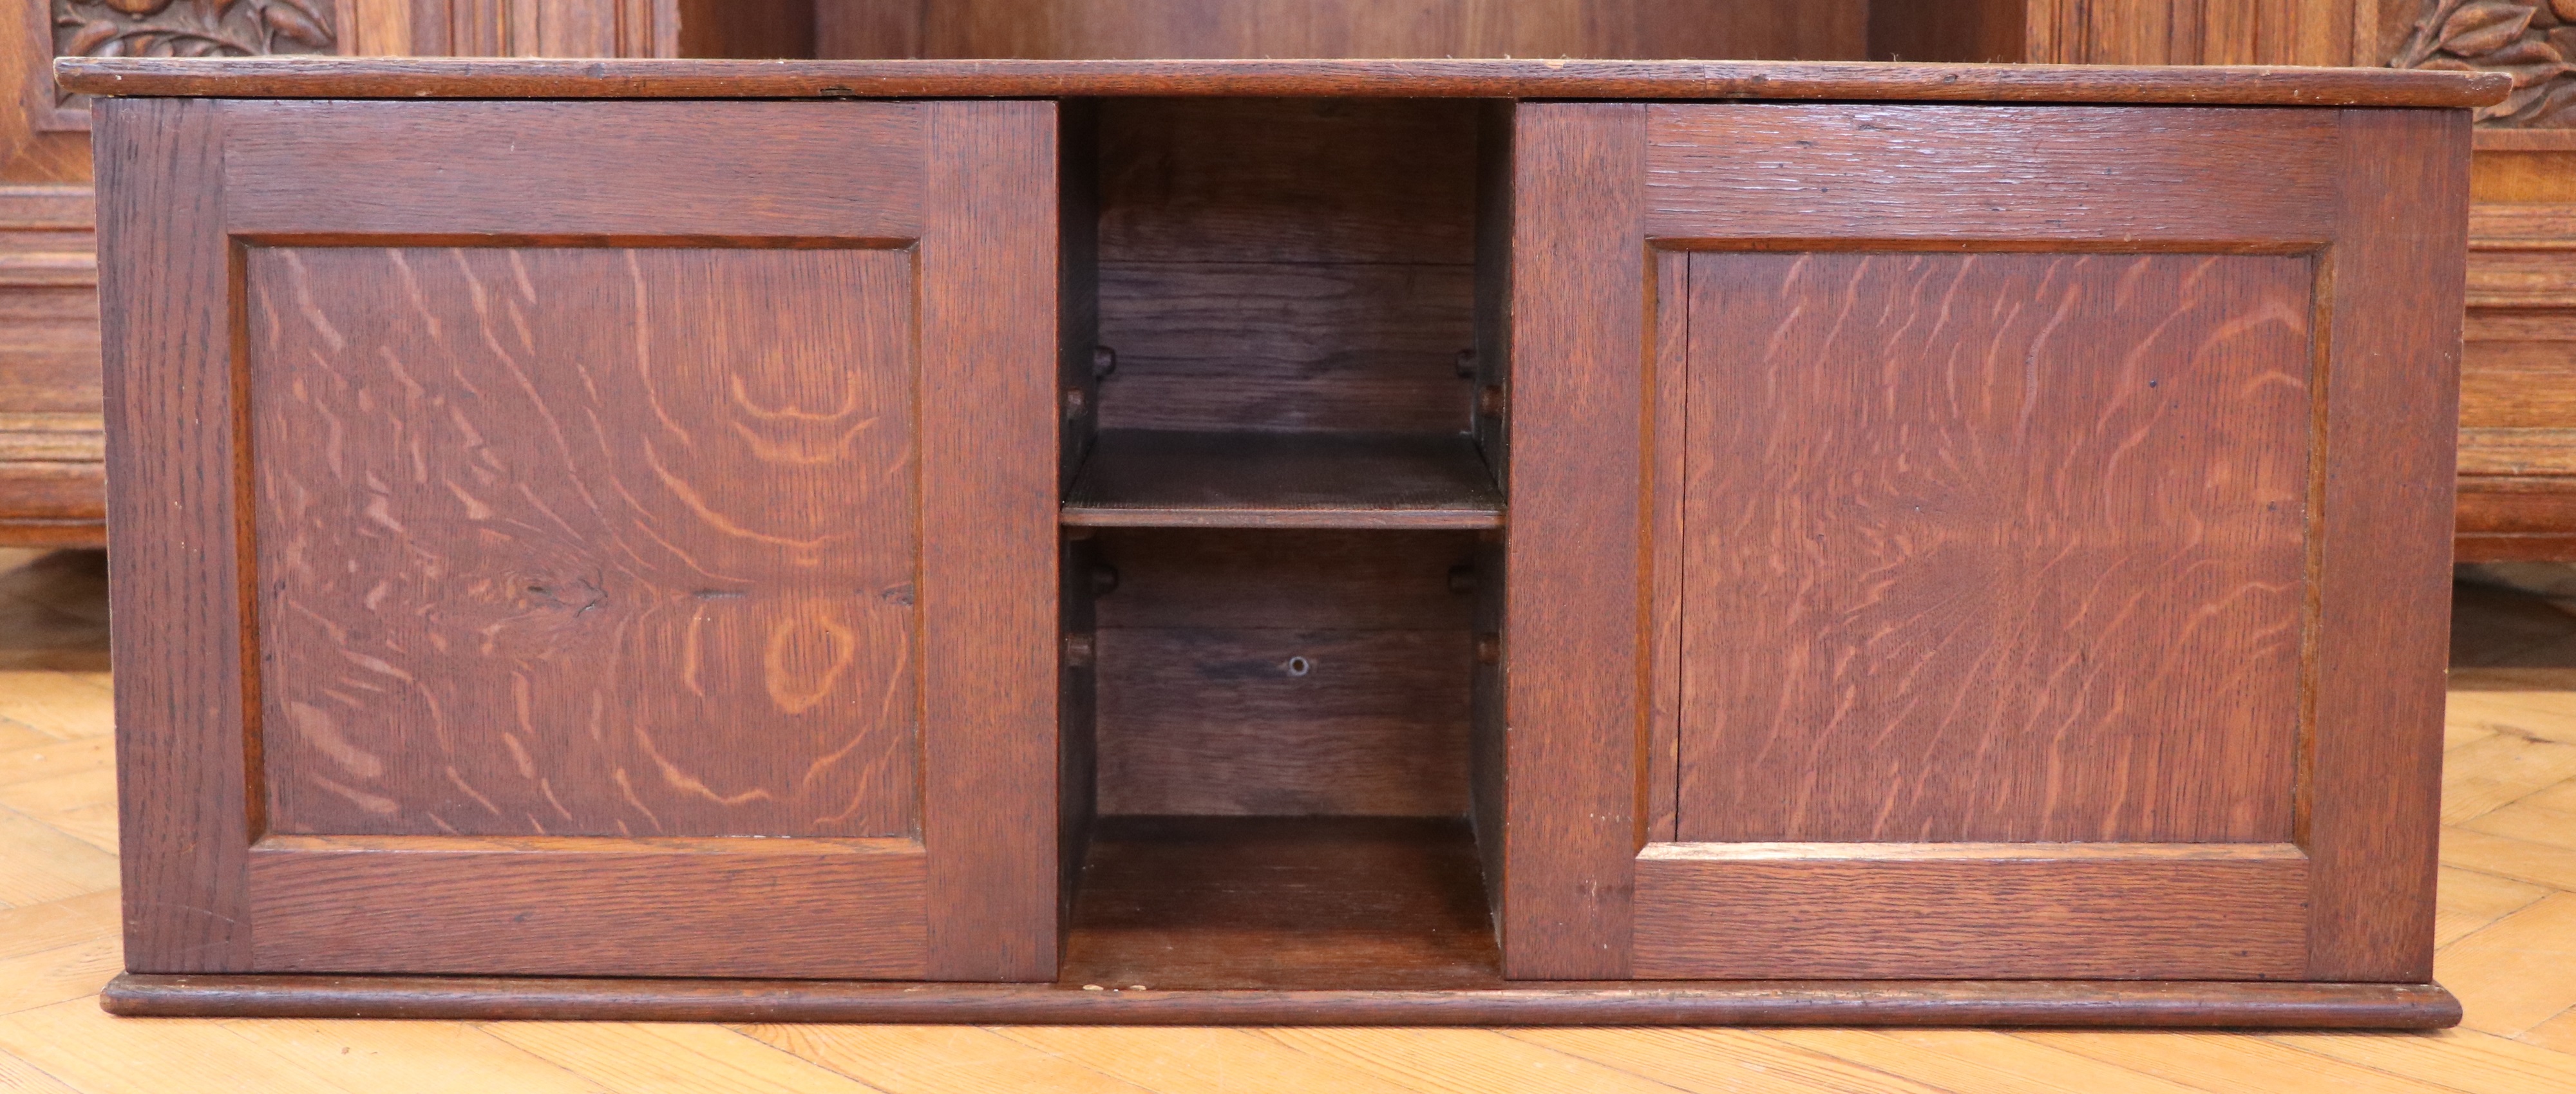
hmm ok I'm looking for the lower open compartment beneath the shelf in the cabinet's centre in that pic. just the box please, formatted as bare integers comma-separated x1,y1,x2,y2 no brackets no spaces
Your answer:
1064,528,1497,988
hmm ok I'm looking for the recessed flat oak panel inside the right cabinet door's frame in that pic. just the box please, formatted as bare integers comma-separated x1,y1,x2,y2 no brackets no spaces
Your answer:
1677,252,2313,842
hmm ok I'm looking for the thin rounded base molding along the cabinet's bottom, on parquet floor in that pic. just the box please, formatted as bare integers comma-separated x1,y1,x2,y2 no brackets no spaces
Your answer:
100,973,2460,1030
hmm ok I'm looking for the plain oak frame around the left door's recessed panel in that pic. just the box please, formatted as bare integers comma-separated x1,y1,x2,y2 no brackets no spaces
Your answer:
98,98,1061,981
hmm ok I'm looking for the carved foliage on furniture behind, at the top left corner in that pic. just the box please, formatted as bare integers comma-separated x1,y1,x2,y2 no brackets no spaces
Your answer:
52,0,332,57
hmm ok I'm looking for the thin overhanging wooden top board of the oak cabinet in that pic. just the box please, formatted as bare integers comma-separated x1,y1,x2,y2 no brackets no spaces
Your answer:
54,57,2512,106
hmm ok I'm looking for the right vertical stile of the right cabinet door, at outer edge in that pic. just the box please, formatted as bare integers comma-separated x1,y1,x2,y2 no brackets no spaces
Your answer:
2298,111,2470,981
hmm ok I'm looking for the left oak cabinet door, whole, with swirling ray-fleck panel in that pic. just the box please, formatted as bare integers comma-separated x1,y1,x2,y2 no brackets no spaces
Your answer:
98,100,1059,981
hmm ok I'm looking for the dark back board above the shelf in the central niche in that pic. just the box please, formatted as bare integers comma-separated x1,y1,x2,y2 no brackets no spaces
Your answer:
1097,98,1476,433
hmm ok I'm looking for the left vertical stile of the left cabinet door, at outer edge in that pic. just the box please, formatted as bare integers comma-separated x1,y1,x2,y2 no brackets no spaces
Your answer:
95,98,255,973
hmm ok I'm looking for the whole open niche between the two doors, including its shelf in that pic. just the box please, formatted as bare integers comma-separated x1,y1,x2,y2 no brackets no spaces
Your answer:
1061,100,1507,988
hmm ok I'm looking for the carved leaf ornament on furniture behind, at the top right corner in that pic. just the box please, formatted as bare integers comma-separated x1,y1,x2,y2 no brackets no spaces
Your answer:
2388,0,2576,129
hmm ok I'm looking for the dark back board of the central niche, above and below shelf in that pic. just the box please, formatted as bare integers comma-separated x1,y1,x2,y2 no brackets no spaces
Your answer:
1095,98,1479,816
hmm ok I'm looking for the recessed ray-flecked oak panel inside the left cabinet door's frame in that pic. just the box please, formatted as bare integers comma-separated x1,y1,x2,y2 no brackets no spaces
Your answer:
247,247,920,836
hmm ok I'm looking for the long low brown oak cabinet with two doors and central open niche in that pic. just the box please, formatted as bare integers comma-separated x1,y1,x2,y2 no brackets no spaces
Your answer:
64,59,2504,1027
